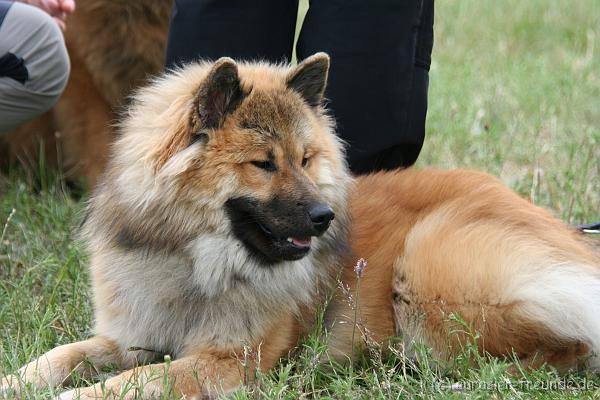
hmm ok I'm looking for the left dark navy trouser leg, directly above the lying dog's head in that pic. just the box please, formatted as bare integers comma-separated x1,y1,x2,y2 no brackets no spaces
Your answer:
166,0,298,67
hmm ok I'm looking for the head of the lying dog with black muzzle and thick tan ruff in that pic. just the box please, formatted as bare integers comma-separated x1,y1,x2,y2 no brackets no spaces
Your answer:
105,53,349,264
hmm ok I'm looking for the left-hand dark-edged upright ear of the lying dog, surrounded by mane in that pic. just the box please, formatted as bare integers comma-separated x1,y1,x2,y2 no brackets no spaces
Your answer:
196,57,248,130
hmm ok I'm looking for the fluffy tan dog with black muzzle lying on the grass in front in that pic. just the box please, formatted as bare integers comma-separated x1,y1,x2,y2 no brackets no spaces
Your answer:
4,53,600,399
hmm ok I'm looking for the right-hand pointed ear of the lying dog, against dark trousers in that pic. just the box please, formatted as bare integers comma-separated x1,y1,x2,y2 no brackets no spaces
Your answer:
287,53,329,107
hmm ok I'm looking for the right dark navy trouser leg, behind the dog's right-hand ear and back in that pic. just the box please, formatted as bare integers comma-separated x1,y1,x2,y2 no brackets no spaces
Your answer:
297,0,433,173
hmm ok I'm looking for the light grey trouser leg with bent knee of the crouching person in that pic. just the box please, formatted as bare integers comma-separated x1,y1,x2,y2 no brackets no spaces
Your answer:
0,0,70,133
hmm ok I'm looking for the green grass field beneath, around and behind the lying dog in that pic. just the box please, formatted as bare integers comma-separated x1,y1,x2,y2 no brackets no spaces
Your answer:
0,0,600,399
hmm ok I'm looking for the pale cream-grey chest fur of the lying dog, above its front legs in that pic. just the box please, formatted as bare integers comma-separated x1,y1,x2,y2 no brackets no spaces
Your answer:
92,235,317,358
